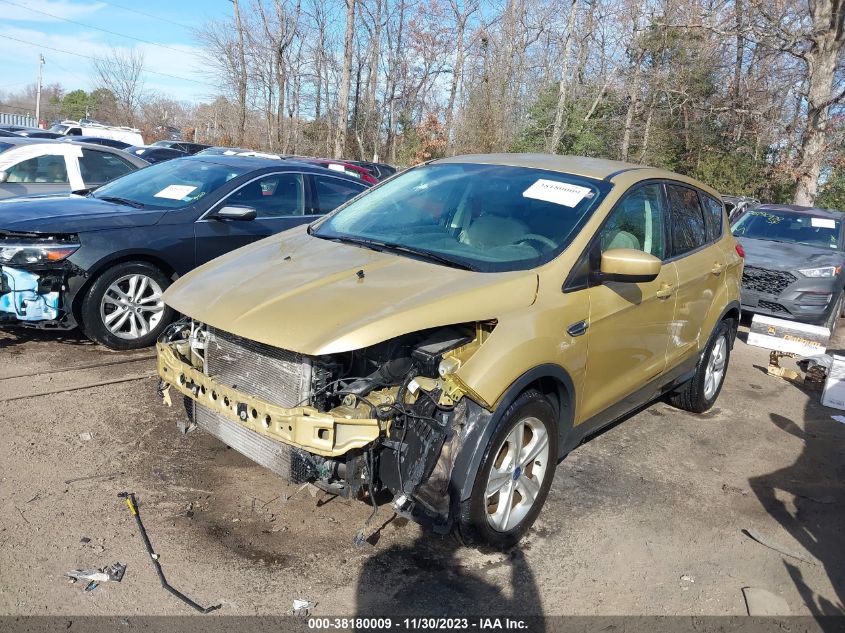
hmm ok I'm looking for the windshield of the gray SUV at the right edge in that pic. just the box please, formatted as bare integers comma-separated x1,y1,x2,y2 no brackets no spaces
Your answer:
731,209,842,249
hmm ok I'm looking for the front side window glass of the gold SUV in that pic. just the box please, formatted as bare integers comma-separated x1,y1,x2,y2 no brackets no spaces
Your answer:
599,183,666,259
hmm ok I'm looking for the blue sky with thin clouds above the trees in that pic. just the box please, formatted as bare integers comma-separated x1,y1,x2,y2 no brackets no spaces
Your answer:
0,0,232,102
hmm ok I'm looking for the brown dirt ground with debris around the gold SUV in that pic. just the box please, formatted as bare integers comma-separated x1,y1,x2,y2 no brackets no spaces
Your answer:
0,318,845,616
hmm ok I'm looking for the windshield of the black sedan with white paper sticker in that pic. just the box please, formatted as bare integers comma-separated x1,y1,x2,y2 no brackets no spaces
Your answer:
92,159,247,209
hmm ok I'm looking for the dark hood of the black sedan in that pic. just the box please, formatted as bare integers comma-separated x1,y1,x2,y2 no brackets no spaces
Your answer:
0,194,165,233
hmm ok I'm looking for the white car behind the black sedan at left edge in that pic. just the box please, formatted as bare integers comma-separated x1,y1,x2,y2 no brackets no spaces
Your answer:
0,137,149,198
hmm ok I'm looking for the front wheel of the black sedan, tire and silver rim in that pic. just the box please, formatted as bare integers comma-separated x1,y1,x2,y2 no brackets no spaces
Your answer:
80,262,174,350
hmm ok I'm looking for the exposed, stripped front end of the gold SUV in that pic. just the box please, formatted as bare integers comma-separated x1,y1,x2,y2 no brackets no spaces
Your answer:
157,319,496,529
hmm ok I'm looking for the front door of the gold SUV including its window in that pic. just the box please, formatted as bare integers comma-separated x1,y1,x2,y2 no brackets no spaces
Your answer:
578,183,678,422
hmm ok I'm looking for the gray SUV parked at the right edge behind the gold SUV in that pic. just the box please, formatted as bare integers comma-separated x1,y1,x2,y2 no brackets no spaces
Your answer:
731,204,845,330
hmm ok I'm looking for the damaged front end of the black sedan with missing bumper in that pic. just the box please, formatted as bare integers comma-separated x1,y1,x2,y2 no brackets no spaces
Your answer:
0,232,83,329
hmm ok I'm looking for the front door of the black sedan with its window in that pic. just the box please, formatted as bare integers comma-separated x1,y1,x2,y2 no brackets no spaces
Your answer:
194,172,313,265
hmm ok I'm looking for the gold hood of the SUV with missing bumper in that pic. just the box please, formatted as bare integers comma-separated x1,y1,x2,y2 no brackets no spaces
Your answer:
164,227,538,355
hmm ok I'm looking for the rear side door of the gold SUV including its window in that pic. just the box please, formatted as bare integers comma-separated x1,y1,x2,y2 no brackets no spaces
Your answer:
666,182,727,366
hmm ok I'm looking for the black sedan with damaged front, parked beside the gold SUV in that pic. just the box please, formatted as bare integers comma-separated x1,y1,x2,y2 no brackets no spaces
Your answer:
0,156,368,349
